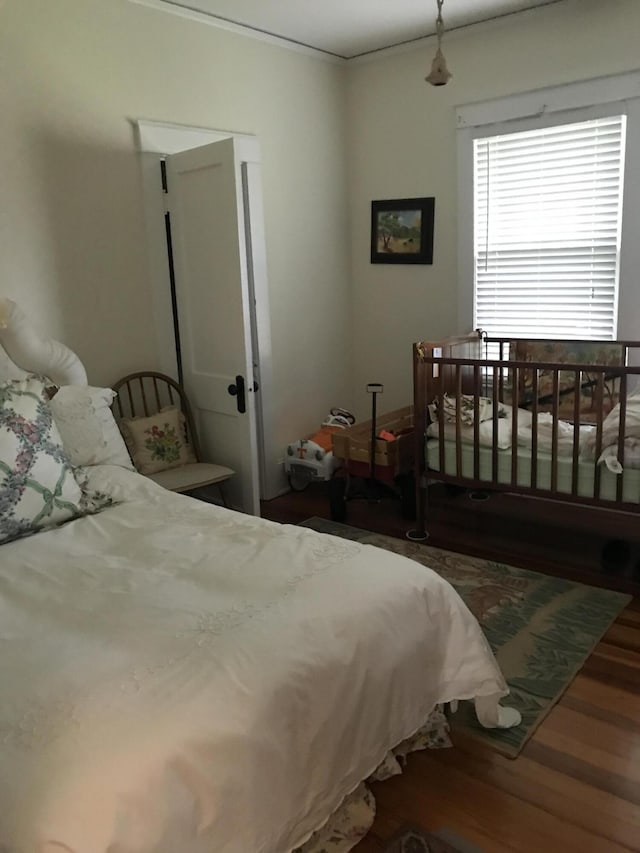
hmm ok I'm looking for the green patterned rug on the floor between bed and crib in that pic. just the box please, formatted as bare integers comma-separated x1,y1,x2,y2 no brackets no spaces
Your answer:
302,518,631,758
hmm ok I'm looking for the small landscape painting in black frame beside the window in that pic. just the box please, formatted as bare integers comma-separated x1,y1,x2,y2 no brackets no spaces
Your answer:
371,196,435,264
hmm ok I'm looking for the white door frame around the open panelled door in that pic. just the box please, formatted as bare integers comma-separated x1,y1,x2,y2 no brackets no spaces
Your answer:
133,119,282,500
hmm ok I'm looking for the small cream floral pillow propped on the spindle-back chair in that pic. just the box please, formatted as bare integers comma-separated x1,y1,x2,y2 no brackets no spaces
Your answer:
120,406,196,474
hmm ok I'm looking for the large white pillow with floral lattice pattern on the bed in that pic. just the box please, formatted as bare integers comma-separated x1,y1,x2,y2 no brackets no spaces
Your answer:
0,376,100,542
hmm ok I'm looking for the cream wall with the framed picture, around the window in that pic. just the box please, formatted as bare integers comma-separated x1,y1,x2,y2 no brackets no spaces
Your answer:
348,0,640,416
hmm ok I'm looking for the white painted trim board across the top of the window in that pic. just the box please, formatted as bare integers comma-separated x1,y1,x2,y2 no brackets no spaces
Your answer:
456,71,640,130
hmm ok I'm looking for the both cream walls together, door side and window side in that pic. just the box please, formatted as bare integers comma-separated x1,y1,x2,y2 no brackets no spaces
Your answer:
6,0,640,462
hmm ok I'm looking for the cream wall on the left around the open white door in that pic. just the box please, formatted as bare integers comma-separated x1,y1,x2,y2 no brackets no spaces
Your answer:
0,0,351,466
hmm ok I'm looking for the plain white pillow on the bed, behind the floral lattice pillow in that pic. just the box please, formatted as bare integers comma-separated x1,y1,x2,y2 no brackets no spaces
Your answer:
50,385,134,471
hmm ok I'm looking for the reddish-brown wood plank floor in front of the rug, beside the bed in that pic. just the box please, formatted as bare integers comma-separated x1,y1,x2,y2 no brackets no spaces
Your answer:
356,601,640,853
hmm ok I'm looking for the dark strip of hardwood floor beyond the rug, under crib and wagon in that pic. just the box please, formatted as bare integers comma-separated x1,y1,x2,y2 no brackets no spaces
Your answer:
262,483,640,595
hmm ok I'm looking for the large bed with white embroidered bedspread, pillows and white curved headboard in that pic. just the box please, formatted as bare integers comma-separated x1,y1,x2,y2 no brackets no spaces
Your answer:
0,300,518,853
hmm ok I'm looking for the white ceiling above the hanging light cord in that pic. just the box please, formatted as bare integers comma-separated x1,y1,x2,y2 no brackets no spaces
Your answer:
156,0,565,59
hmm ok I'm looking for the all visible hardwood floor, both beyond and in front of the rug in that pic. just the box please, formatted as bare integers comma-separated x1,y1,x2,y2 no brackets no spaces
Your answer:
263,484,640,853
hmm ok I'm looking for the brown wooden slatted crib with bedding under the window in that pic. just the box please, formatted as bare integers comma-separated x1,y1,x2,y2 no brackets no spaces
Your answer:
413,331,640,538
